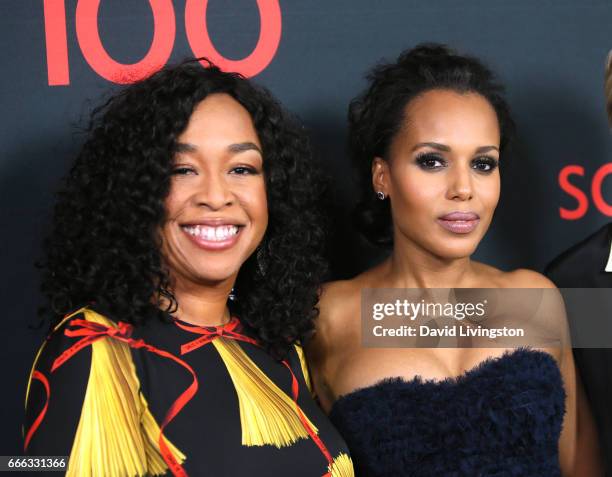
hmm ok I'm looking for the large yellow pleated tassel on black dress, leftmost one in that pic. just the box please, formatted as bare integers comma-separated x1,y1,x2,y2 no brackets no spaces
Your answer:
66,309,185,477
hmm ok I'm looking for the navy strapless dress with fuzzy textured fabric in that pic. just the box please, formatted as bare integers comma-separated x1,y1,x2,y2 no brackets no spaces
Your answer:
330,348,565,477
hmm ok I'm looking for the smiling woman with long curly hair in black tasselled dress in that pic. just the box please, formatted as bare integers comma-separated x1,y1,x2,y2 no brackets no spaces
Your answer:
24,62,353,476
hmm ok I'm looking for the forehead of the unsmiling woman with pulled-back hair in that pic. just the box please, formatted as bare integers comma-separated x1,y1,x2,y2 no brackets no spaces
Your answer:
396,90,500,146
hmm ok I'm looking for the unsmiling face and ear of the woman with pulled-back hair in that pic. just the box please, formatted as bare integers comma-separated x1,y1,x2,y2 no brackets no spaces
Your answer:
372,90,500,259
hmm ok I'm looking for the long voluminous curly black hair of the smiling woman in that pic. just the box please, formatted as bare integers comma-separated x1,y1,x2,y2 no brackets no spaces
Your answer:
39,59,327,358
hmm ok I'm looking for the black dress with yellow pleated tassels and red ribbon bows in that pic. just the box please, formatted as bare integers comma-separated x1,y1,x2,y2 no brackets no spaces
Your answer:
24,307,353,477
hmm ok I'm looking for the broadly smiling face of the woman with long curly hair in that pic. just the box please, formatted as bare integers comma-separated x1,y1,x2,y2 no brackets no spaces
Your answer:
161,94,268,285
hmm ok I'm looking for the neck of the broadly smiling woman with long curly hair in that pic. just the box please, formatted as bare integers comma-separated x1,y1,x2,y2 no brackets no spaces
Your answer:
166,277,235,326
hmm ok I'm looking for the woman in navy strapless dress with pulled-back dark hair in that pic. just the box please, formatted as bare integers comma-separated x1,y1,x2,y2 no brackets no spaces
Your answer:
307,44,597,477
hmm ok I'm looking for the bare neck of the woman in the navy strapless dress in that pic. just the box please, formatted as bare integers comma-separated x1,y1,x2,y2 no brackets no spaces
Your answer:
387,233,473,288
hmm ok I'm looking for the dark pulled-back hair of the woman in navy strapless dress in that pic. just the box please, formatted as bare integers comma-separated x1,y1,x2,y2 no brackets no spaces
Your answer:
348,43,514,246
